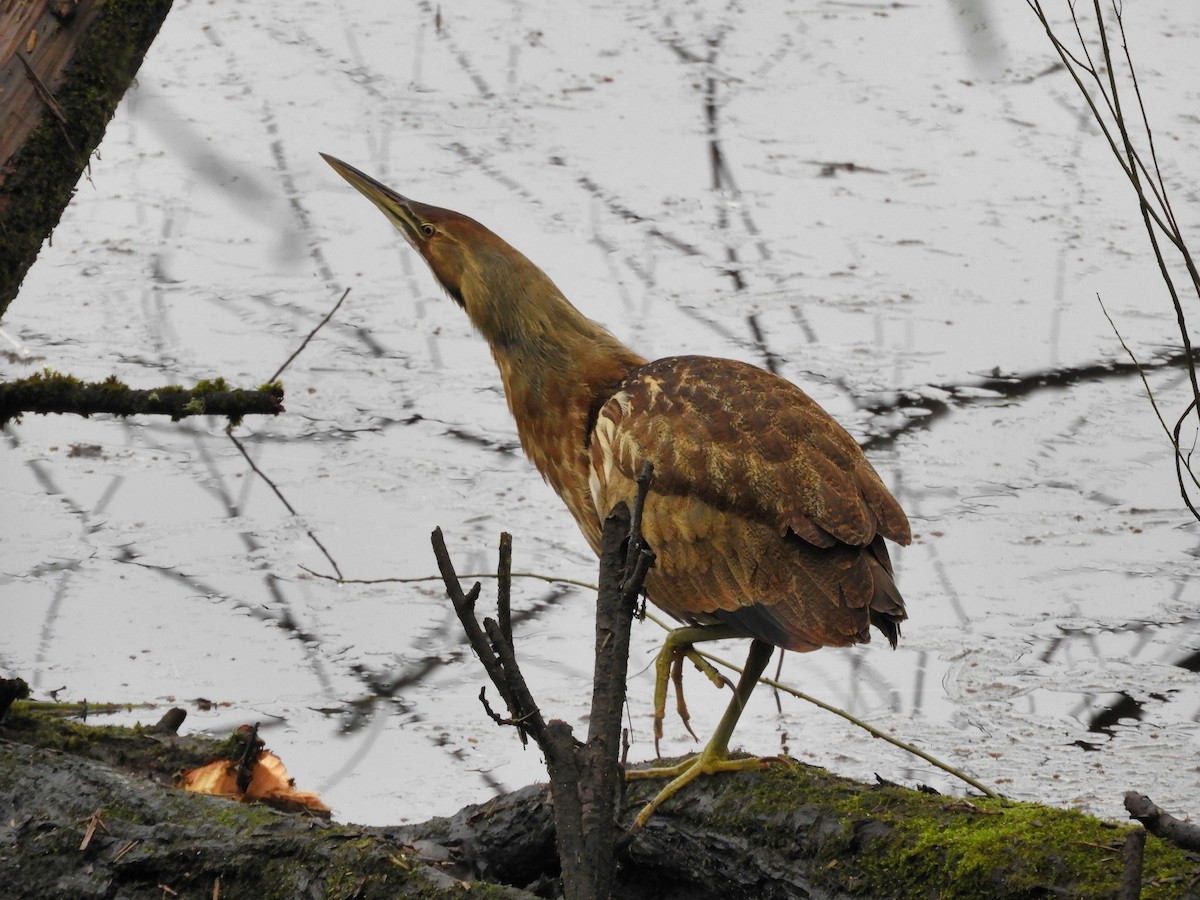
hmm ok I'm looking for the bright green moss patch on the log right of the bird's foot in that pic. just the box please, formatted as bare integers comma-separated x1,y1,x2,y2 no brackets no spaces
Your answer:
686,766,1196,900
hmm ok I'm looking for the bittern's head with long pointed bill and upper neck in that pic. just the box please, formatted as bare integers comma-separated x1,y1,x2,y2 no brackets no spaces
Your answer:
322,154,562,340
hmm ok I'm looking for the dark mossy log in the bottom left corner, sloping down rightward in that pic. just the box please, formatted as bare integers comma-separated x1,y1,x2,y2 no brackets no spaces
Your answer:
0,703,530,900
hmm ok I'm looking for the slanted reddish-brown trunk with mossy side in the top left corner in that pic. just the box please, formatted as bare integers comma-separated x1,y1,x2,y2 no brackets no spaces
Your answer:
0,0,170,317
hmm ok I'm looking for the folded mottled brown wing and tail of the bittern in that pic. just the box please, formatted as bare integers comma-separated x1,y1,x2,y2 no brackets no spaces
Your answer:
589,356,910,650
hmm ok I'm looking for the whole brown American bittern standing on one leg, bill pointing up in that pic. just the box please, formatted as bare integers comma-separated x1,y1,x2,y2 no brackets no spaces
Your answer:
323,155,910,824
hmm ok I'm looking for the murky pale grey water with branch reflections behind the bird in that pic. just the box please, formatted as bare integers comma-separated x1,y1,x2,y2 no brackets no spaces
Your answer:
0,0,1200,822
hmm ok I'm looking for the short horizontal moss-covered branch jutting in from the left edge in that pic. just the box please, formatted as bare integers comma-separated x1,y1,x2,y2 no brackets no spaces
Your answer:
0,370,283,426
